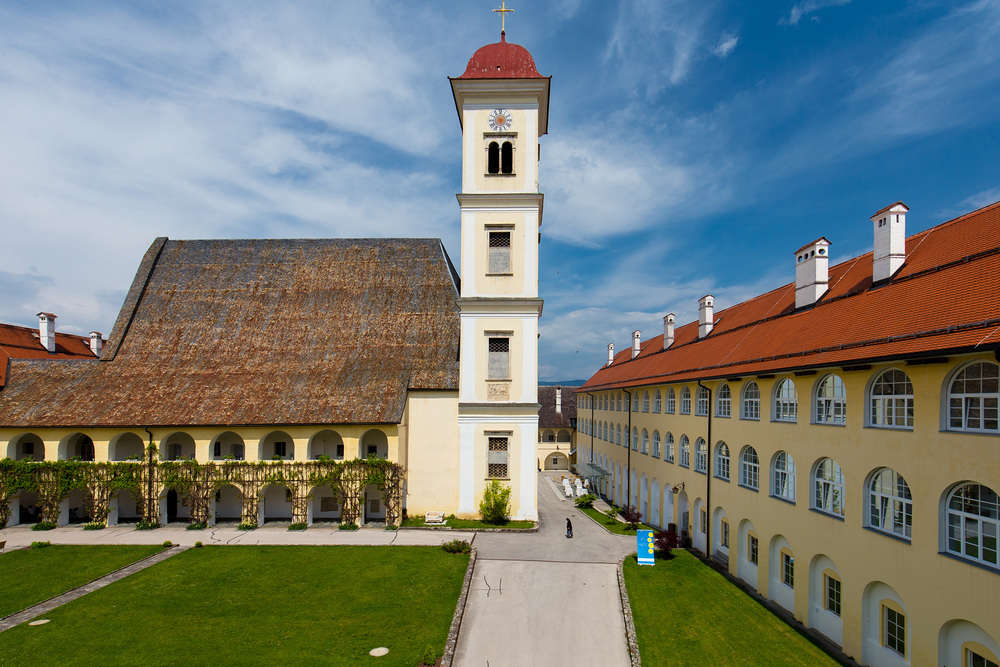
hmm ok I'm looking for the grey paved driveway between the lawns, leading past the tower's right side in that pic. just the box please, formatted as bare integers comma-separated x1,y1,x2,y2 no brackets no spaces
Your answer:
454,473,635,667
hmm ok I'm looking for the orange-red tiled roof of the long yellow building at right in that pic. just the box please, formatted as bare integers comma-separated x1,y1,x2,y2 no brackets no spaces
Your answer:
581,202,1000,391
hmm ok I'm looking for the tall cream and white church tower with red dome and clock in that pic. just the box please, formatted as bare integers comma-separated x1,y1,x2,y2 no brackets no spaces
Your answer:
450,32,551,519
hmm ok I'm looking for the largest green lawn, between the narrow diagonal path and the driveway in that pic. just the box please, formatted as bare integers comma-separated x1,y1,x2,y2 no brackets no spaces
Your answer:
0,546,469,667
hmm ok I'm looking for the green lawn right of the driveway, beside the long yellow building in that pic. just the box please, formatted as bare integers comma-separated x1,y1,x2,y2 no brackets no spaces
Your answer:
624,549,839,667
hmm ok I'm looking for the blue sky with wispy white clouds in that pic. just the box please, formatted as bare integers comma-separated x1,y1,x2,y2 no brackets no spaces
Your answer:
0,0,1000,380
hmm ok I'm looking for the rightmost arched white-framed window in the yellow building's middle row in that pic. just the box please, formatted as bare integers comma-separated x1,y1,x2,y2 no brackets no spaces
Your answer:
948,484,1000,567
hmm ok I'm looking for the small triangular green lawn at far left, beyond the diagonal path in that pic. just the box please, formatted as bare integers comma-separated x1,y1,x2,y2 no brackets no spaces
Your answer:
0,545,162,617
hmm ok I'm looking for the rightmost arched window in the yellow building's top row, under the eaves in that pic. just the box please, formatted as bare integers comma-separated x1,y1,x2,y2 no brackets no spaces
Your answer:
948,361,1000,433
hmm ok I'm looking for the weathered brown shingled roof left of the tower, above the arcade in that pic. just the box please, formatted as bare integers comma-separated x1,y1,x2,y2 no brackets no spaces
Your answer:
0,239,459,427
